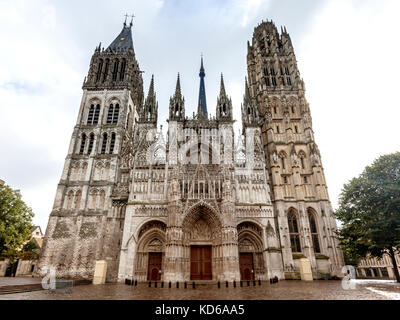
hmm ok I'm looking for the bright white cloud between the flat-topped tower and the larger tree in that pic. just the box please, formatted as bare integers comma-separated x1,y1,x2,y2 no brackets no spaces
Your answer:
295,0,400,207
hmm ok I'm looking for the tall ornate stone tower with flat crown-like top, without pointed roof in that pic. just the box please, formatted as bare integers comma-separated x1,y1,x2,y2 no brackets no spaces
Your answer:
245,21,343,274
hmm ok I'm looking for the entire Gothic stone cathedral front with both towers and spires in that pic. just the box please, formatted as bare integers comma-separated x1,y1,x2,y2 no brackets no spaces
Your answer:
39,21,344,281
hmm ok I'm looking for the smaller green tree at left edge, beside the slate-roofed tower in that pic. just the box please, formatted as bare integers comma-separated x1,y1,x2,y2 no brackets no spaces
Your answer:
0,185,33,261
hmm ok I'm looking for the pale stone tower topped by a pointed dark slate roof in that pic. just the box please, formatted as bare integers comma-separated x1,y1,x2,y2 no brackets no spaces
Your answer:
40,23,144,280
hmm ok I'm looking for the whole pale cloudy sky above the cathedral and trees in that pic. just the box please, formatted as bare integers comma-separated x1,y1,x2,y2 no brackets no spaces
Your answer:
0,0,400,231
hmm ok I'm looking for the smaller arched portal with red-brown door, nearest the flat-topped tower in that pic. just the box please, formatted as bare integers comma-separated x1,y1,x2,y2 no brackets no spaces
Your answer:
237,221,266,280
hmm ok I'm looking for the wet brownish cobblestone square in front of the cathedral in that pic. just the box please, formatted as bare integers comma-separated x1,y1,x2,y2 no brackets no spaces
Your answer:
0,280,400,300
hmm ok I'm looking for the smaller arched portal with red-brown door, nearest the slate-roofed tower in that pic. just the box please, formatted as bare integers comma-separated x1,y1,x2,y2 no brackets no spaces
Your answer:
135,220,166,281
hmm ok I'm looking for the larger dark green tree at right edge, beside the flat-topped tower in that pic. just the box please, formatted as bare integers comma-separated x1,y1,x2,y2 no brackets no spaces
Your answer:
336,152,400,282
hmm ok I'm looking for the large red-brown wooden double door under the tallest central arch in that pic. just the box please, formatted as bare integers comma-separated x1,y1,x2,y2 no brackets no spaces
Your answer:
190,246,212,280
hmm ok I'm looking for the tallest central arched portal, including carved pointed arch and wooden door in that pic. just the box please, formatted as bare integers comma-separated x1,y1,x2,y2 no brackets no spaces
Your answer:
182,204,222,280
